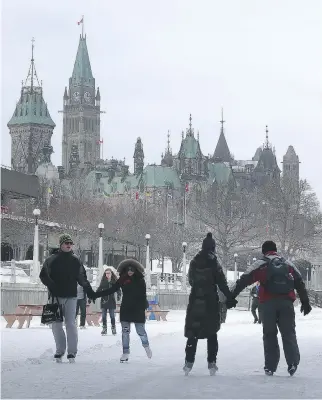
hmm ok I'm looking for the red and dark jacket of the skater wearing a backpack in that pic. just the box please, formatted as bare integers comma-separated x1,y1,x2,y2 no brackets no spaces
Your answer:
232,251,308,303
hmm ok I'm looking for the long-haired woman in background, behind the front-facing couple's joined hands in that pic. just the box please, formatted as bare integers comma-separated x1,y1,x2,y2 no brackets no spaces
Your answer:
97,265,122,335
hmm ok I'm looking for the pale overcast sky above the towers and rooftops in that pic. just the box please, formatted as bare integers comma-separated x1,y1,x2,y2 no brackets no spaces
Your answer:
1,0,322,202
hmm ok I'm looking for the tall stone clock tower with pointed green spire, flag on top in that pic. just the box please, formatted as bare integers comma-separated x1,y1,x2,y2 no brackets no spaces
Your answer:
62,34,101,175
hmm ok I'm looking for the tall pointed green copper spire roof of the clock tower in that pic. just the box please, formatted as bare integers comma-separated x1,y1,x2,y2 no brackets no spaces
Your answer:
72,36,94,84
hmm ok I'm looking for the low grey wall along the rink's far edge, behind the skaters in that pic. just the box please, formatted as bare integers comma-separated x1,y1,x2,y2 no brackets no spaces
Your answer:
1,282,250,314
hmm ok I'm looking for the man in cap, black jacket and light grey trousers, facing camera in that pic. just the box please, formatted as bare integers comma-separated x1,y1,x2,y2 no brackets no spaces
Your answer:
39,233,95,362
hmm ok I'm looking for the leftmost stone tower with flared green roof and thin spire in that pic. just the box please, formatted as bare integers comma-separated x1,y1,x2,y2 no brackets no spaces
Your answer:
8,39,55,174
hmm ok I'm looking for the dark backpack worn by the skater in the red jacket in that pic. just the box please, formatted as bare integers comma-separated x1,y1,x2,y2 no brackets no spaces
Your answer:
265,257,294,294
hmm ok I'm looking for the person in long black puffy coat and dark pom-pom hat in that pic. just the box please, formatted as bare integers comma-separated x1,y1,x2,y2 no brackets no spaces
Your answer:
183,233,237,375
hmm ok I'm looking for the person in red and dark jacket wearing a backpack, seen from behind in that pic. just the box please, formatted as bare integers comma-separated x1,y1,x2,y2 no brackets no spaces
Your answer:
232,240,312,376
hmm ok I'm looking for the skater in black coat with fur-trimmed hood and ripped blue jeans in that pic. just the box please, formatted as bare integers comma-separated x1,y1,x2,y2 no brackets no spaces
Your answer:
96,259,152,362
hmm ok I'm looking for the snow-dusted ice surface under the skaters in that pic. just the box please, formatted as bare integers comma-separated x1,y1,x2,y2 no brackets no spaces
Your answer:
1,309,322,399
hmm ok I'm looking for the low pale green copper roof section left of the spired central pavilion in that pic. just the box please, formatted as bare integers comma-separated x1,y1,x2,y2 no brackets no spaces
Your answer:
142,165,182,189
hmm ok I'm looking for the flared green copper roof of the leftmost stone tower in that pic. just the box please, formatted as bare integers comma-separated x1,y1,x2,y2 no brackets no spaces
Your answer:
8,87,55,128
